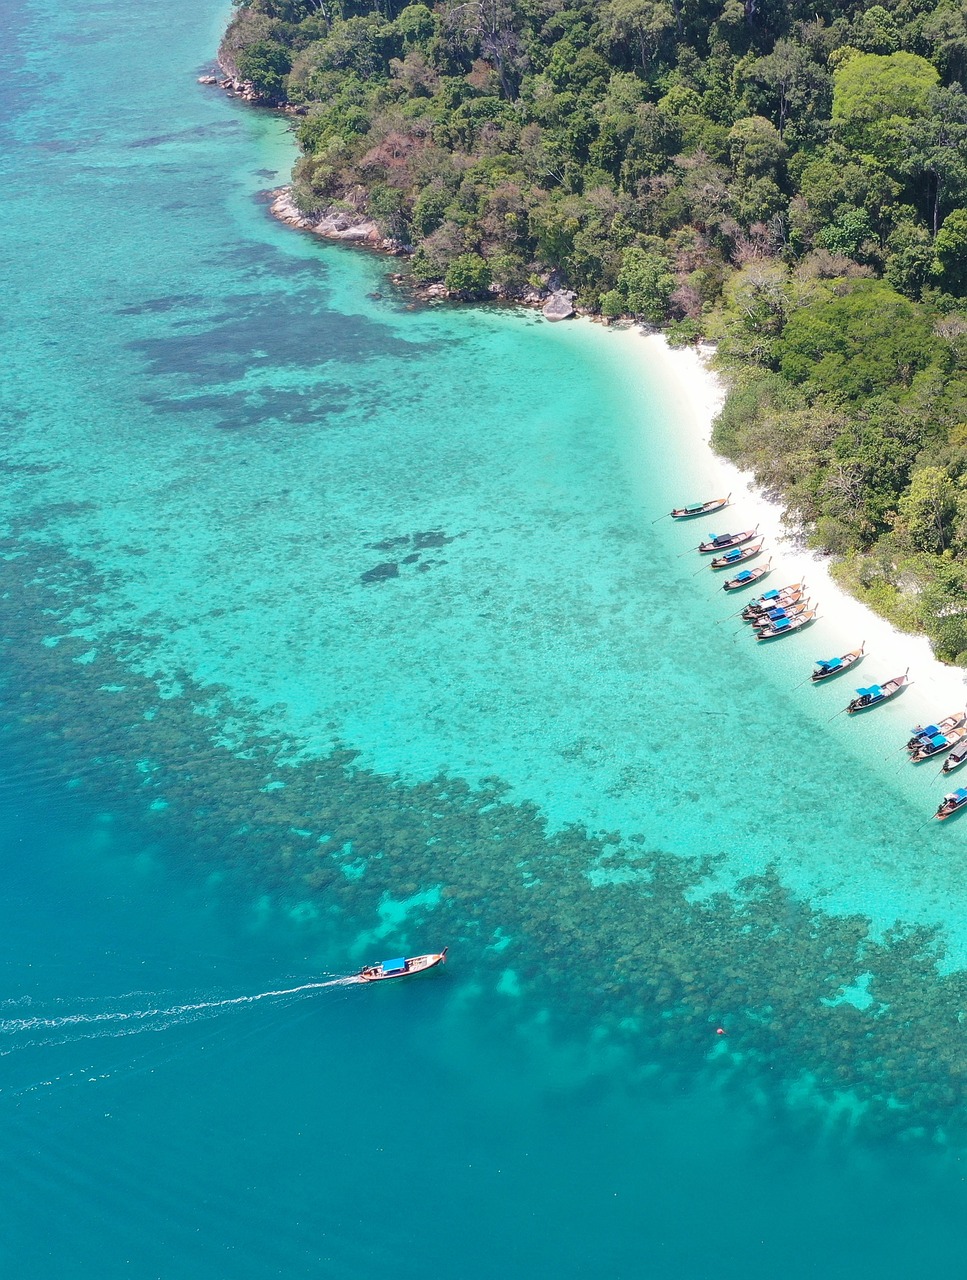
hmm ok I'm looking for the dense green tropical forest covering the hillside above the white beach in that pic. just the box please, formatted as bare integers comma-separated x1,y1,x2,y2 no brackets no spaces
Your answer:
220,0,967,664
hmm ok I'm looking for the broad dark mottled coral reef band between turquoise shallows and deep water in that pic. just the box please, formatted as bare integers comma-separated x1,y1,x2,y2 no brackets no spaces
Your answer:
0,527,967,1142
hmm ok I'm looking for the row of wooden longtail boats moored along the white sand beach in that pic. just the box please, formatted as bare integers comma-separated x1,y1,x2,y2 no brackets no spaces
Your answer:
669,494,967,822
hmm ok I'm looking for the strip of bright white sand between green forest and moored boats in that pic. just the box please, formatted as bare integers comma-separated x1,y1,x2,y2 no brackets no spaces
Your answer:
635,330,967,723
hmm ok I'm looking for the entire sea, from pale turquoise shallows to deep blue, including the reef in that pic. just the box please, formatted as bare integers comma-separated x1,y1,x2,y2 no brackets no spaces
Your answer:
0,0,967,1280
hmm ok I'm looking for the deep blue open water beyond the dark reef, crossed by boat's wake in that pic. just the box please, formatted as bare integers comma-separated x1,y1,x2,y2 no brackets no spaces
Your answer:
7,791,963,1277
